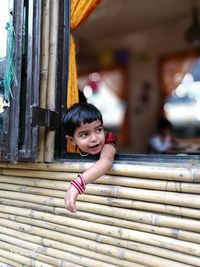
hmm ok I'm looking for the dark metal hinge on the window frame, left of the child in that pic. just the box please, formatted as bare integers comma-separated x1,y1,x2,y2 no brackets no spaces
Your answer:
31,106,59,131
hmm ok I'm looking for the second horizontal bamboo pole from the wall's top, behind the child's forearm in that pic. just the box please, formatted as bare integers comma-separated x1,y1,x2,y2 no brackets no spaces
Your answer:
0,170,200,194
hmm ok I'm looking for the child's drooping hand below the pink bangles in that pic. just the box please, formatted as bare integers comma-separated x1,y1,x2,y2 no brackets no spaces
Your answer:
64,185,78,212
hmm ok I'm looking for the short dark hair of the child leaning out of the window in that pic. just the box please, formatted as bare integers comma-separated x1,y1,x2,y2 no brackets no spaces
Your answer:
62,103,103,137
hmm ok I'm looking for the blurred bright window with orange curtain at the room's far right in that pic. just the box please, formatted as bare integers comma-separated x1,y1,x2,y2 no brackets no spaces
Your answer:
162,54,200,153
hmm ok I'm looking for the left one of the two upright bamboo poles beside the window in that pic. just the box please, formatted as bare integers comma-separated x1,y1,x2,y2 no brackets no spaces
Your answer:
38,0,50,162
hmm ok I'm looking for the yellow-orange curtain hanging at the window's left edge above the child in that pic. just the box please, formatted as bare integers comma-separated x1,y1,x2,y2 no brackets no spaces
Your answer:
67,0,101,152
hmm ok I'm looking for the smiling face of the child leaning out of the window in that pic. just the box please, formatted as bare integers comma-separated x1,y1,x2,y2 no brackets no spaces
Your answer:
74,120,105,155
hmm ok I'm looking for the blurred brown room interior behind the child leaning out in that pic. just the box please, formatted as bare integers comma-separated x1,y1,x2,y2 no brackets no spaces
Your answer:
74,0,200,153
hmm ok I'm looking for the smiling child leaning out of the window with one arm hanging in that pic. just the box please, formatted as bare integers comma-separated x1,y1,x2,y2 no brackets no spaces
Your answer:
62,103,117,212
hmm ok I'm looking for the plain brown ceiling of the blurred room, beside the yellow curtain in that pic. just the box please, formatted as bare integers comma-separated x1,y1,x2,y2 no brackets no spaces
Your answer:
75,0,200,41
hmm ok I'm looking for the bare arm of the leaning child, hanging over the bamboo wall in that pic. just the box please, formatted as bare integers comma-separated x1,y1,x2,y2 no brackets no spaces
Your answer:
64,144,116,212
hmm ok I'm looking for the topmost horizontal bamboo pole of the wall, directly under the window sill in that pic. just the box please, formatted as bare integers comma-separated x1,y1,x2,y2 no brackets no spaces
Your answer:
0,161,200,182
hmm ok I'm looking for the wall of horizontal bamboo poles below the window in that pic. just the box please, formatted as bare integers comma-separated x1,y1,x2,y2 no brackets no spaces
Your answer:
0,162,200,267
